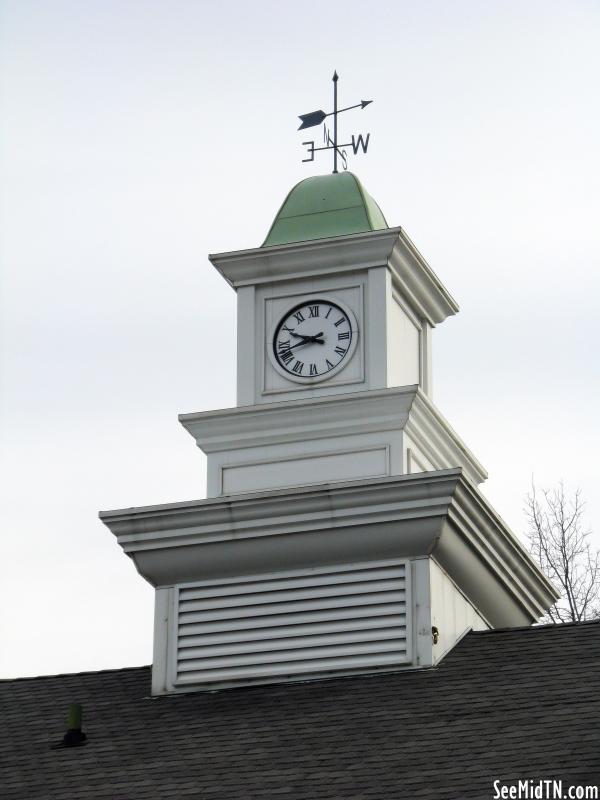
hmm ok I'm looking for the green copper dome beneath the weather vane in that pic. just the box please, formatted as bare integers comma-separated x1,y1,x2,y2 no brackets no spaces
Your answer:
263,172,388,247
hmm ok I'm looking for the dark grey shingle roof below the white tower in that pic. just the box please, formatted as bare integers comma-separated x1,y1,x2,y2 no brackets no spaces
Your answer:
0,623,600,800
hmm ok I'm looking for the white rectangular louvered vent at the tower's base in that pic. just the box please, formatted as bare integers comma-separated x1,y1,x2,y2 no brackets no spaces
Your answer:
171,561,411,688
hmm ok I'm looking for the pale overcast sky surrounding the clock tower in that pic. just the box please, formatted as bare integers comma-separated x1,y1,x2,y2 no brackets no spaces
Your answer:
0,0,600,677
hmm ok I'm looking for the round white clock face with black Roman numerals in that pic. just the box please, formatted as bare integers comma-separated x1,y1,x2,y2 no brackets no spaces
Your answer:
267,295,358,383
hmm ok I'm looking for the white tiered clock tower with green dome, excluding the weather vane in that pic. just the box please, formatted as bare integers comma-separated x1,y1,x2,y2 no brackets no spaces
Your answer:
101,173,555,694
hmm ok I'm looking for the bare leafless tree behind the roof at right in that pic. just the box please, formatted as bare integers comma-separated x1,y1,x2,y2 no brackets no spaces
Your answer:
525,479,600,623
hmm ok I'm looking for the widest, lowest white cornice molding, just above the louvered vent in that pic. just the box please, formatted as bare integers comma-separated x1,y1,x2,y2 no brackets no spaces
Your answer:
100,469,556,627
